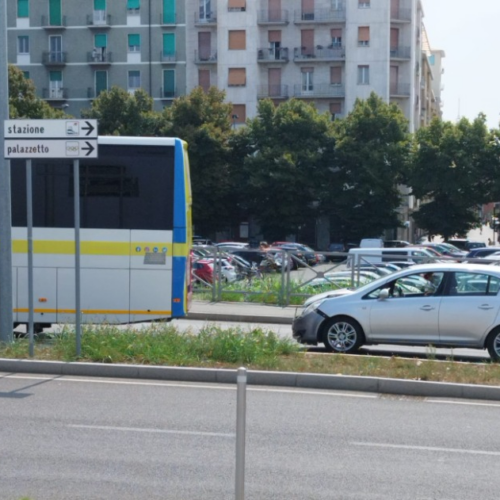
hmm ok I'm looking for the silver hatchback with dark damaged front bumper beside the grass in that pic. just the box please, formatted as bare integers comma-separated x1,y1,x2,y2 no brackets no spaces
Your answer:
292,263,500,361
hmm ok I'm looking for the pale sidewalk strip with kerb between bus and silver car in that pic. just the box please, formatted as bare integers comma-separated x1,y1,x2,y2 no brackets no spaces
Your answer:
187,300,296,325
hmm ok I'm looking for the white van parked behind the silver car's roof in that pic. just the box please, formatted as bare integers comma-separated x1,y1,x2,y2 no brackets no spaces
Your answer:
347,247,436,267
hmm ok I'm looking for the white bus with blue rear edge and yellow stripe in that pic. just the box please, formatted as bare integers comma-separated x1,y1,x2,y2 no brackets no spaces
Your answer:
11,136,192,332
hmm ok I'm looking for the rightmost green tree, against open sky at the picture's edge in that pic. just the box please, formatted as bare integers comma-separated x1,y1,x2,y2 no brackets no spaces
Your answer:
409,115,500,238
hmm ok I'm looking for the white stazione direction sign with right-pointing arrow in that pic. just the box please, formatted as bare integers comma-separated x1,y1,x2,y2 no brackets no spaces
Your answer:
4,120,97,139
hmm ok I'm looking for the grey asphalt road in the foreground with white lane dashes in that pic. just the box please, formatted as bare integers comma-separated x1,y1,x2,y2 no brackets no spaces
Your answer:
0,374,500,500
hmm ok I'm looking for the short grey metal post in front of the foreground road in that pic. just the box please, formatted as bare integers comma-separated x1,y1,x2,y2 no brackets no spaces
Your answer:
235,367,247,500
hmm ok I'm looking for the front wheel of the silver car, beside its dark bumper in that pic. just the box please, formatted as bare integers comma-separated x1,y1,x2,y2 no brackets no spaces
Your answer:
322,316,365,354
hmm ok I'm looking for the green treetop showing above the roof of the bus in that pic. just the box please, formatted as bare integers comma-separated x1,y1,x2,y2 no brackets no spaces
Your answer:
81,86,162,136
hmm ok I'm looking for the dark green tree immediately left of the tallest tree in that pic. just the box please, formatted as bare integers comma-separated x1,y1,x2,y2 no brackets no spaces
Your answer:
239,99,334,239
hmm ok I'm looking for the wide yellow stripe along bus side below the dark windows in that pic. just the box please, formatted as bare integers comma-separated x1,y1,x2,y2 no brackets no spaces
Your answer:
12,240,189,257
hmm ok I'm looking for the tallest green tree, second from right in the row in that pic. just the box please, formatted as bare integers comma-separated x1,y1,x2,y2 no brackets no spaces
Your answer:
322,93,411,241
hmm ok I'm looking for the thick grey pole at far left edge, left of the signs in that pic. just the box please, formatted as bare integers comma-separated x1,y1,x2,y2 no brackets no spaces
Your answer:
0,0,13,343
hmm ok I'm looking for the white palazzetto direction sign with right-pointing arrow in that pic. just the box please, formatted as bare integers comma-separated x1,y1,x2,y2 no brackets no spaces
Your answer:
4,139,97,160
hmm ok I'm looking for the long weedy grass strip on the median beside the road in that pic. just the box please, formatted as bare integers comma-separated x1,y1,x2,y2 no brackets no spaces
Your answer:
0,323,500,386
